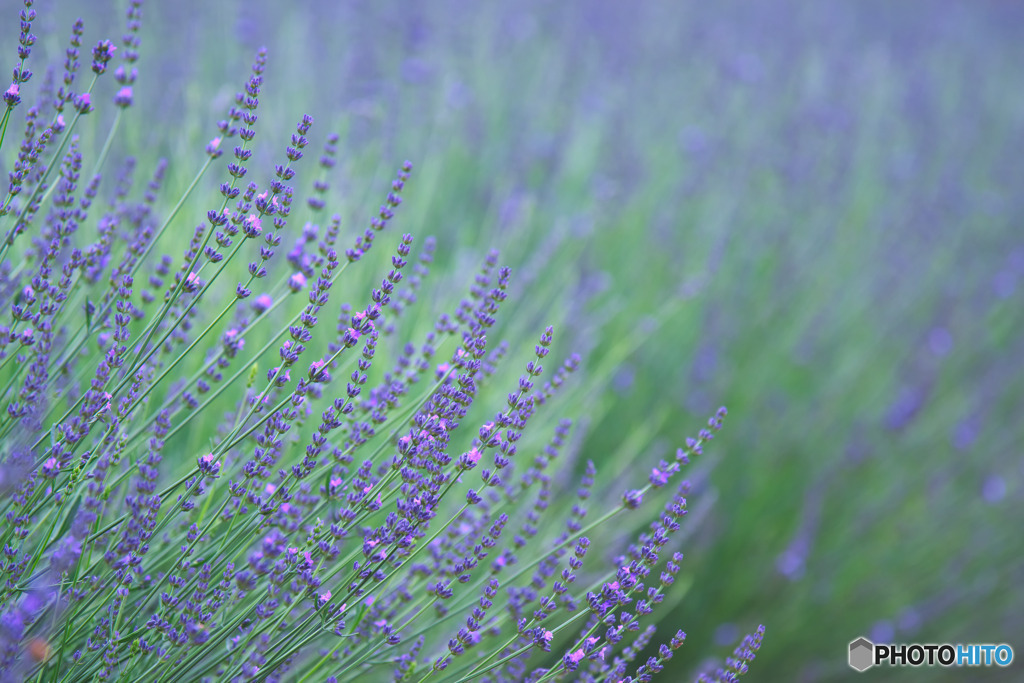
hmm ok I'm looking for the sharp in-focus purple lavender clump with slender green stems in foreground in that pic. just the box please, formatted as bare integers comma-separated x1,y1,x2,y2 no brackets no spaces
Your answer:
0,0,763,683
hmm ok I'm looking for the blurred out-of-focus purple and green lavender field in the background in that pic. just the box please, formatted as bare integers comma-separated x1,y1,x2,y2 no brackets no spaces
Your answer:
0,0,1024,681
